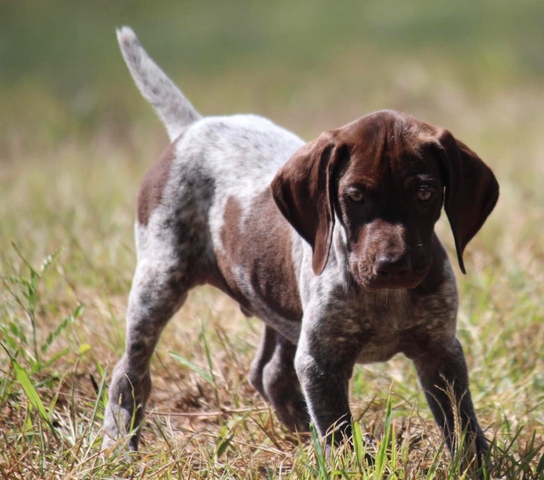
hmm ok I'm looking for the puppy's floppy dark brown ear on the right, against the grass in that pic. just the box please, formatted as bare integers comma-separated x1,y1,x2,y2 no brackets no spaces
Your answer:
438,130,499,273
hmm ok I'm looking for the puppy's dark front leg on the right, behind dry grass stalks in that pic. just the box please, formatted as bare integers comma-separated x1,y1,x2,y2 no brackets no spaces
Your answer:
414,339,488,464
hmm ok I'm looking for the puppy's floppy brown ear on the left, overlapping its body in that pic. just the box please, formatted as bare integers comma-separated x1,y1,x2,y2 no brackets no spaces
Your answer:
271,132,344,275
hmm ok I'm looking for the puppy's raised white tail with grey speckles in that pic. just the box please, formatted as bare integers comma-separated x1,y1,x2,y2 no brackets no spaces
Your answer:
117,27,202,141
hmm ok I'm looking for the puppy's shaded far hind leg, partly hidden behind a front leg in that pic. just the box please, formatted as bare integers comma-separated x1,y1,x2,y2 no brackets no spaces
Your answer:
249,326,310,432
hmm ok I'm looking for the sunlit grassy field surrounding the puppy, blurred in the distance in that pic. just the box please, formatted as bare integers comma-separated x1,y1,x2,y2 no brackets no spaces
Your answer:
0,0,544,480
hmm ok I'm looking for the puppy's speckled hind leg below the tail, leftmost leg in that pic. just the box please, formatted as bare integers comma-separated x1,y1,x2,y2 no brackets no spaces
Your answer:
103,239,189,451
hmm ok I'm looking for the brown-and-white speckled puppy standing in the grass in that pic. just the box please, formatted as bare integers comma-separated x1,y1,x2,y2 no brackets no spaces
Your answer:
104,27,499,464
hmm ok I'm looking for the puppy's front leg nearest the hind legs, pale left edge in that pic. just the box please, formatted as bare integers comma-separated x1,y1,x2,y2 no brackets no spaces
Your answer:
295,327,355,444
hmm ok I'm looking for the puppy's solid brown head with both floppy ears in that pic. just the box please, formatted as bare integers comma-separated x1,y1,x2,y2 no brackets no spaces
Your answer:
272,111,499,290
